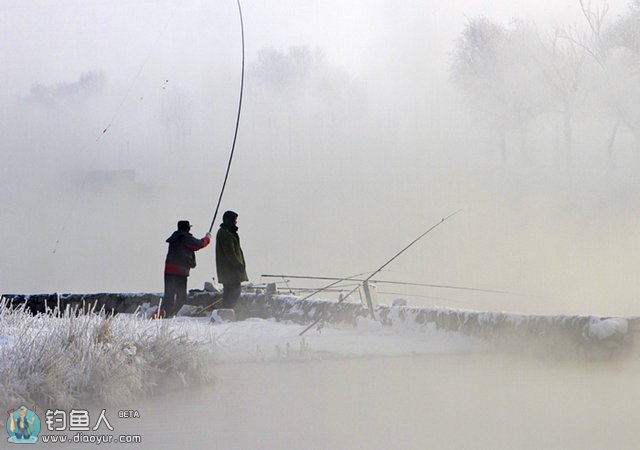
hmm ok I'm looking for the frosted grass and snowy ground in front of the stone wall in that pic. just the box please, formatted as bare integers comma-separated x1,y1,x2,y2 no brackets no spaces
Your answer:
0,308,483,407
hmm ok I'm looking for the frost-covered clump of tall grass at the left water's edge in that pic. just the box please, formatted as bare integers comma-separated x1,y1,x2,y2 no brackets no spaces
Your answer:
0,302,215,408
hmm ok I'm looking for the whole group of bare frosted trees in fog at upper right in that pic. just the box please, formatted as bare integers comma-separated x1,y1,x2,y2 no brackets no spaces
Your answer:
451,0,640,166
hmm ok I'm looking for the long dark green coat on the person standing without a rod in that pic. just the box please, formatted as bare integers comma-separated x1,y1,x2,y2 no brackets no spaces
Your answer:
216,224,249,284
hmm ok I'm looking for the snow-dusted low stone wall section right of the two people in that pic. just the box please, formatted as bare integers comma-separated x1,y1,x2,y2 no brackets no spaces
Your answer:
238,295,640,359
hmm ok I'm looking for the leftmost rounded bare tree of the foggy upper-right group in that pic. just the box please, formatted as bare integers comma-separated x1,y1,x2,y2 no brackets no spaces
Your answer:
451,17,548,163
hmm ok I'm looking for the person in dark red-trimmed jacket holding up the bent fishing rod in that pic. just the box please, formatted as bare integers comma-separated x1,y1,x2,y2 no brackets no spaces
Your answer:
162,220,211,317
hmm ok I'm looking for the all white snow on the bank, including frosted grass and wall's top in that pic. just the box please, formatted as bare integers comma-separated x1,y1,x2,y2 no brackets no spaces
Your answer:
0,300,633,412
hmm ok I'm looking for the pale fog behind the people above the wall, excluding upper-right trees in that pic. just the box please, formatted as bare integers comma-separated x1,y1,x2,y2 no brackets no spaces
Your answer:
0,0,640,315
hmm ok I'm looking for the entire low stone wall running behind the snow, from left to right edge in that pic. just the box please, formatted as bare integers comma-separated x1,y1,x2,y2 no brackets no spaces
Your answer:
2,290,640,358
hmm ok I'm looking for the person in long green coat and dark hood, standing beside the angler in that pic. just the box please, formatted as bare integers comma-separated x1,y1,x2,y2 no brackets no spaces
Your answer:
216,211,249,309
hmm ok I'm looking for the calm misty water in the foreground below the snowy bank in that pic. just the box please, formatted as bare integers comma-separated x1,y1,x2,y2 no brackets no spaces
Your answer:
92,354,640,449
